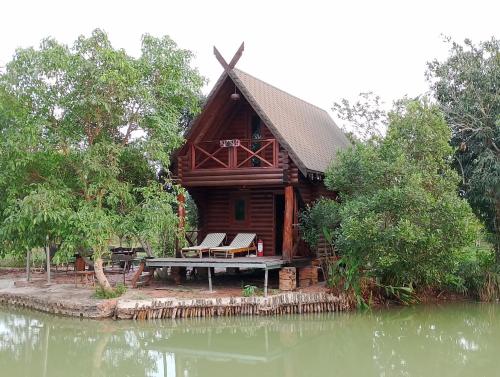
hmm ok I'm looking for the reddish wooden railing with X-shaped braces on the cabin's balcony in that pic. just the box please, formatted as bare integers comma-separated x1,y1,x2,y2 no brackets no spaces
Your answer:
190,139,278,170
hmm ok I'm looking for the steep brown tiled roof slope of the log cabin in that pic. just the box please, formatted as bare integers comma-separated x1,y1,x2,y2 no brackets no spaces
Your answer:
229,69,350,174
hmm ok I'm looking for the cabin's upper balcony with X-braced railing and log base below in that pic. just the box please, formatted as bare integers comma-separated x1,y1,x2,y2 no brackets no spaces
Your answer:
178,139,288,187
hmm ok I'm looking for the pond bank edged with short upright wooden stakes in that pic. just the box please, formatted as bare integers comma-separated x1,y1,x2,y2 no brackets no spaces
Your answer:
0,284,352,320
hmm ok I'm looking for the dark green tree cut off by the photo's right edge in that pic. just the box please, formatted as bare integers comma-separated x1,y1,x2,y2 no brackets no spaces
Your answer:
427,38,500,264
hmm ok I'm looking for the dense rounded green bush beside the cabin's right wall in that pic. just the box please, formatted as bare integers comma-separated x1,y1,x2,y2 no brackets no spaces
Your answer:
303,100,478,304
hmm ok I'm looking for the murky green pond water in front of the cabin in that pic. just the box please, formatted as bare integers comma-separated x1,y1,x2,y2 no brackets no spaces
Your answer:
0,303,500,377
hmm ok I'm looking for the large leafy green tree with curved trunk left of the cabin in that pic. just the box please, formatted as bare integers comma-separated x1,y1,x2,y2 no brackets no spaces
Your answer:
0,29,204,291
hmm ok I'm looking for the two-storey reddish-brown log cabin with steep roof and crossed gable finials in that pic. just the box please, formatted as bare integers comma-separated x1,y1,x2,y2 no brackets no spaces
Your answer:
173,45,350,261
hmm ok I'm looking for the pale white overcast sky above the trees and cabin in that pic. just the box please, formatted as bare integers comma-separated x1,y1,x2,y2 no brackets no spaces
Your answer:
0,0,500,116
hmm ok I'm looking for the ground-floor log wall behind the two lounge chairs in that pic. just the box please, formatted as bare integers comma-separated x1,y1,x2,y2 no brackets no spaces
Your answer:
193,189,275,256
